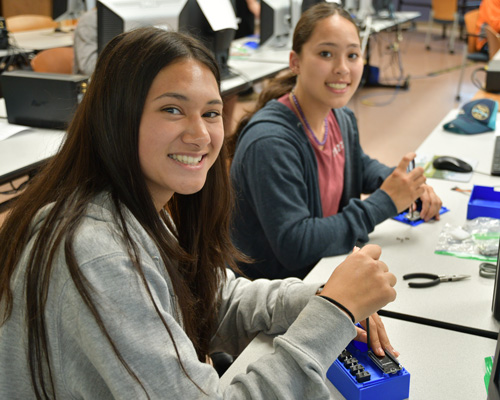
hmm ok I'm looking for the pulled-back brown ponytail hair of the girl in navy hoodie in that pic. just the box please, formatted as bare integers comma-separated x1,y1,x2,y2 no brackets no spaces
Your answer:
227,3,359,159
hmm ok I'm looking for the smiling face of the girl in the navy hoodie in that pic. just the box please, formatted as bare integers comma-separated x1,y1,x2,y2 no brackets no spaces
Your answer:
290,14,363,112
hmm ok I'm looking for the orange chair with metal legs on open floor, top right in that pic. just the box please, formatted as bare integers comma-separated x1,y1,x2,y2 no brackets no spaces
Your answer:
425,0,458,54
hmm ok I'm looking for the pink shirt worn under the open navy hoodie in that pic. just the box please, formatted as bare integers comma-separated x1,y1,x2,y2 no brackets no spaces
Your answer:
278,94,345,217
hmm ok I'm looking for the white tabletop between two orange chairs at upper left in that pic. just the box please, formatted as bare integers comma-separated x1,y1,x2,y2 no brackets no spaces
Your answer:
0,28,73,57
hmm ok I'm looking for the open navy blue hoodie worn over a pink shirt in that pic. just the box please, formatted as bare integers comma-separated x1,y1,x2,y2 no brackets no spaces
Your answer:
231,100,397,279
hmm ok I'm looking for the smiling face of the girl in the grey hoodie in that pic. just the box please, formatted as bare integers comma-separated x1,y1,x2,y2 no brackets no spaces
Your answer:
139,59,224,210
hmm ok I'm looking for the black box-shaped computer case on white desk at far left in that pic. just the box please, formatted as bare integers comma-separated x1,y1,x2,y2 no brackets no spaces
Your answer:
0,70,88,129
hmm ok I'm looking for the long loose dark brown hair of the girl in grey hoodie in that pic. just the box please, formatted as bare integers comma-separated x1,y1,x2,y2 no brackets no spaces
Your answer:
0,28,240,398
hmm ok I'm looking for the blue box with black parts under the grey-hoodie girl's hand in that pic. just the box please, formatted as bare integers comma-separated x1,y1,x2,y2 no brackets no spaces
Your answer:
326,341,410,400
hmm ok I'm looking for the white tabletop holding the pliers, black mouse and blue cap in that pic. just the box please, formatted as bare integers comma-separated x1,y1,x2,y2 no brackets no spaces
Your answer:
308,111,500,337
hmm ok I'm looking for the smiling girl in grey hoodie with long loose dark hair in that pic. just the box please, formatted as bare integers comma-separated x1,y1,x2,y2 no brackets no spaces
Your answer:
0,27,396,400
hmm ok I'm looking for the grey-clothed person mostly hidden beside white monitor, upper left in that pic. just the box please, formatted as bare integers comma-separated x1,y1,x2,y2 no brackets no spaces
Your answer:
73,7,97,76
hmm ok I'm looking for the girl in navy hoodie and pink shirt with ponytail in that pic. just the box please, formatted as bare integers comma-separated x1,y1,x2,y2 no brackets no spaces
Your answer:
231,3,441,279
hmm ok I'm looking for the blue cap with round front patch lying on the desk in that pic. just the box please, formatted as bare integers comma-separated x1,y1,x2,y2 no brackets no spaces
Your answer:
443,99,498,135
